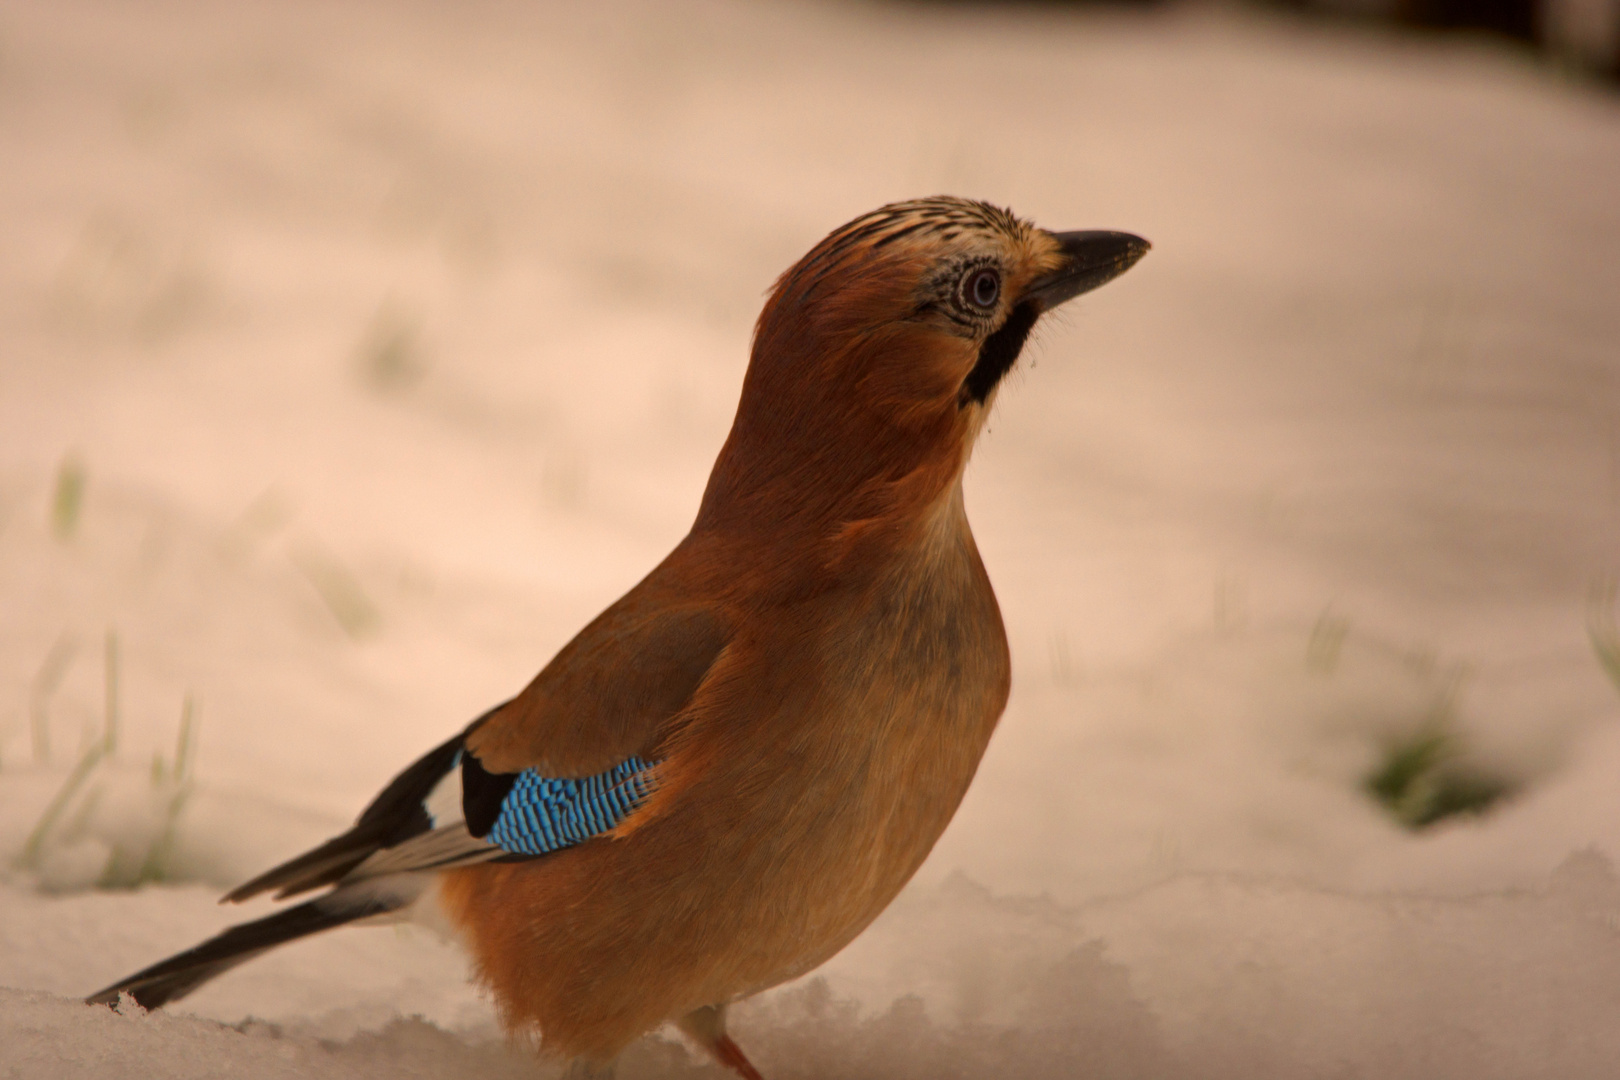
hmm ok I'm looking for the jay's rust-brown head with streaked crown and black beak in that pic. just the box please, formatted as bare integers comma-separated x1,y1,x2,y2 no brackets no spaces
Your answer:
698,196,1149,544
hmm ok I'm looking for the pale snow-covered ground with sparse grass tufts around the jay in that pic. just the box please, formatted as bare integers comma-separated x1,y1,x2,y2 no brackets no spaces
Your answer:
0,0,1620,1080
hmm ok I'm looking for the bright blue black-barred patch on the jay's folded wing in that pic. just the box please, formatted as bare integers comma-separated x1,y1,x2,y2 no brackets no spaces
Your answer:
483,758,658,855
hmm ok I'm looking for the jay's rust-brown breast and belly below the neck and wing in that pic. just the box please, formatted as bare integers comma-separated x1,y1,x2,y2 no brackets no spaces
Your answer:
441,484,1009,1057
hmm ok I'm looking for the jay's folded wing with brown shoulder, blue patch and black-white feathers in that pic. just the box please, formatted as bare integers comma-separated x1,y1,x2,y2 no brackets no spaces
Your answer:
225,591,729,902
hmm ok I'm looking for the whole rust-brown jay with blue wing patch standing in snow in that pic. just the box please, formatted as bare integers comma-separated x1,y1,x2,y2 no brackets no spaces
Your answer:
87,198,1149,1077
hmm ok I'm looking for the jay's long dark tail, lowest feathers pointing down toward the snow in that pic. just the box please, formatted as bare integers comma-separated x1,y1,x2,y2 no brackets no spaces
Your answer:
84,891,405,1009
